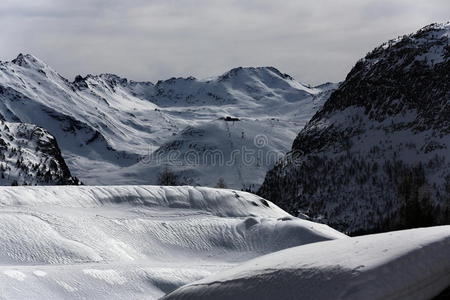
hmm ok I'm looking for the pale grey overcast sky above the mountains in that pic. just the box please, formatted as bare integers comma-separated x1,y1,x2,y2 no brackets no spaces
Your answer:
0,0,450,84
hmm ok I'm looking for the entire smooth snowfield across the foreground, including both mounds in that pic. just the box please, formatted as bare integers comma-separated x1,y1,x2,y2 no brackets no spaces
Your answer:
0,186,450,299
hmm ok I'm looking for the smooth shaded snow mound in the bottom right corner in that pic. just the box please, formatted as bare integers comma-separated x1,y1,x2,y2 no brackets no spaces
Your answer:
164,226,450,300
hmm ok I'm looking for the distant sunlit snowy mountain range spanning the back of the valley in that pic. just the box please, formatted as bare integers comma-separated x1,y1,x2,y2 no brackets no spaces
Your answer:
0,54,335,188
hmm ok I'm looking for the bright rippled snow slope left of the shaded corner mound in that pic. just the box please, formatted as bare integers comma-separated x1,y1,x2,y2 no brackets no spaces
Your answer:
0,186,348,299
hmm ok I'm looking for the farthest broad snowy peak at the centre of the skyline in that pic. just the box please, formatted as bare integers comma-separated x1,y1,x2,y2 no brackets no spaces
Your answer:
150,67,321,107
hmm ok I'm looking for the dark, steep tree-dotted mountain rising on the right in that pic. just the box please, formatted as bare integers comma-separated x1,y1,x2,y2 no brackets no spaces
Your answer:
260,24,450,233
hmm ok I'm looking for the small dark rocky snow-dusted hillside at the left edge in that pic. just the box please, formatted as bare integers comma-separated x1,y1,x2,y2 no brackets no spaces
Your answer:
0,121,78,185
